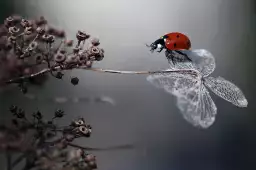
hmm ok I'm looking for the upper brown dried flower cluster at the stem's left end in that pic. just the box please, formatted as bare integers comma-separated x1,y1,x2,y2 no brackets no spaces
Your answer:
0,15,104,93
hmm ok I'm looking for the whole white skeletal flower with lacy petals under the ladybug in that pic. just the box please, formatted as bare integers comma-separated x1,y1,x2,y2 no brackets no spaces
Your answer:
147,49,248,128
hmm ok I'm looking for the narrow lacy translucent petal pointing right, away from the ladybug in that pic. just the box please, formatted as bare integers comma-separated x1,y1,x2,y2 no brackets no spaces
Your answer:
204,77,248,107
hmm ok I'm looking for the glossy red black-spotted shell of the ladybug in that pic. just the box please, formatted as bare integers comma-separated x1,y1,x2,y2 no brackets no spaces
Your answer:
165,32,191,50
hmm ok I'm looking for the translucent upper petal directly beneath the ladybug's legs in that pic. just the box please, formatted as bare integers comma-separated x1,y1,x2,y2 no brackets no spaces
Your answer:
165,49,216,77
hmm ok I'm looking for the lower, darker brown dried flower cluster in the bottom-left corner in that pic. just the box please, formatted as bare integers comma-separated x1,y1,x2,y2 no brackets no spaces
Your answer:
0,106,97,170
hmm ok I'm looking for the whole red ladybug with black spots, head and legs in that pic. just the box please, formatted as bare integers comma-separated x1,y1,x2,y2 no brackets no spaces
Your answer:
147,32,191,61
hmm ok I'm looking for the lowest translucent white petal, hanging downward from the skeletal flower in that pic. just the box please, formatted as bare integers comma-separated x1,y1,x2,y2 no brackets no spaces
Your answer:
177,85,217,128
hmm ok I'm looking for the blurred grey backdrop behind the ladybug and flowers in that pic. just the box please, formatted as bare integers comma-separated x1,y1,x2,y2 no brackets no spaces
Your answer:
0,0,256,170
